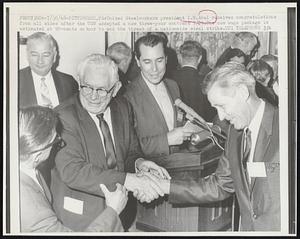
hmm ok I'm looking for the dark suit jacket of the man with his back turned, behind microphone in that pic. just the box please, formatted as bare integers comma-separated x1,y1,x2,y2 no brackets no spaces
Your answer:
172,66,216,121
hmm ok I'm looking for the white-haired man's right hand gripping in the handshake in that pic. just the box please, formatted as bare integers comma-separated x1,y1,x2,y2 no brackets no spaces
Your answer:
124,173,164,203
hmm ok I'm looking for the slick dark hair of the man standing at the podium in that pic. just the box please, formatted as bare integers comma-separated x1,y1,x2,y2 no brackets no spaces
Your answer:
134,33,167,59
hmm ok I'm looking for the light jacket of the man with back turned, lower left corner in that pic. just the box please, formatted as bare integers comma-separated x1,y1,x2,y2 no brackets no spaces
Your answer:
20,171,123,232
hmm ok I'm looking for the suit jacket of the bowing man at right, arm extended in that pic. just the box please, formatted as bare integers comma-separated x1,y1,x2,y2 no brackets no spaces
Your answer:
169,103,280,231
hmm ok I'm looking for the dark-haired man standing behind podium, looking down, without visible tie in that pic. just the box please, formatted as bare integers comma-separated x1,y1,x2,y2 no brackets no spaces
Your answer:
124,34,196,156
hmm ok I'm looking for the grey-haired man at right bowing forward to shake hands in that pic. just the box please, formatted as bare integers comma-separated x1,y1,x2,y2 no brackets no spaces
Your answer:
156,62,280,231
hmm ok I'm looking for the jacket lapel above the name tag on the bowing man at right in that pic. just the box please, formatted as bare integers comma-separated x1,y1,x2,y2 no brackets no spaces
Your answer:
251,102,274,192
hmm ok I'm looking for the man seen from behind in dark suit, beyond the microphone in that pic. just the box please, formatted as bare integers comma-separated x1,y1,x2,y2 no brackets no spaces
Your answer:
172,41,215,121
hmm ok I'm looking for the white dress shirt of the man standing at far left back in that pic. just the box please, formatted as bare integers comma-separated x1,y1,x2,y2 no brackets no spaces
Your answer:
31,71,59,108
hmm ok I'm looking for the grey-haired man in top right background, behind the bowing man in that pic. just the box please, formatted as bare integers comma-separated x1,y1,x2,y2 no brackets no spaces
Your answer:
218,32,260,66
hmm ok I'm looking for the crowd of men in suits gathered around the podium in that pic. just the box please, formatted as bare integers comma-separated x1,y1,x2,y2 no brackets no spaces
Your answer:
19,32,280,232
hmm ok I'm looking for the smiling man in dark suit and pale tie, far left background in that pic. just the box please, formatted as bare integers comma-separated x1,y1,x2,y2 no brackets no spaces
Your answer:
19,32,78,108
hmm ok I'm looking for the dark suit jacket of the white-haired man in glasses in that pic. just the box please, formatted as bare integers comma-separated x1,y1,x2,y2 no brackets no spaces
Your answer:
51,94,140,231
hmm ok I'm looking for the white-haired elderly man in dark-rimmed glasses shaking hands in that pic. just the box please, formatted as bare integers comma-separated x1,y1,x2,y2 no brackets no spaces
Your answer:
51,54,168,231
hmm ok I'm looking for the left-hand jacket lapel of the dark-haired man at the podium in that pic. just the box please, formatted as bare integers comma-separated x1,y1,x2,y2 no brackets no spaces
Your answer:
138,75,169,132
